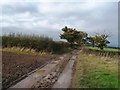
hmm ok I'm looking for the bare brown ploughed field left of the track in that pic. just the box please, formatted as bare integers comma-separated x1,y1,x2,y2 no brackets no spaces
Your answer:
2,50,55,88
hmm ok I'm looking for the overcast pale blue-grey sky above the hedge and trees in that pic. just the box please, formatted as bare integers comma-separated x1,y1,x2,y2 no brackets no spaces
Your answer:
0,0,118,46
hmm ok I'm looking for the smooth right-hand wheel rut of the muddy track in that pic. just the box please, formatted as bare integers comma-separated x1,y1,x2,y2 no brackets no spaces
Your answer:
52,49,79,88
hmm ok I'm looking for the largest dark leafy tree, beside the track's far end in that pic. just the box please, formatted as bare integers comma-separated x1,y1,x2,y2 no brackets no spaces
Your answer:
60,26,87,47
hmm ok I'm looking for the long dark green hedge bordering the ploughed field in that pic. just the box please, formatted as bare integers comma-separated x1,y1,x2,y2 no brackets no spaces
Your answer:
2,33,62,52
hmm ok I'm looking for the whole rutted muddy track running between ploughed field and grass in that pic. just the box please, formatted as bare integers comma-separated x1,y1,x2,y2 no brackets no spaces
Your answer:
8,49,80,88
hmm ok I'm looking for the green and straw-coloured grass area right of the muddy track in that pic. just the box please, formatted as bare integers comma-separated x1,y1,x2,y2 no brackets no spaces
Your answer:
72,53,118,88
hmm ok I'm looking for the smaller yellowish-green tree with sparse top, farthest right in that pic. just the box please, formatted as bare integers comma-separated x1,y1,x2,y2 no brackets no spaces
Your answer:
93,34,110,50
